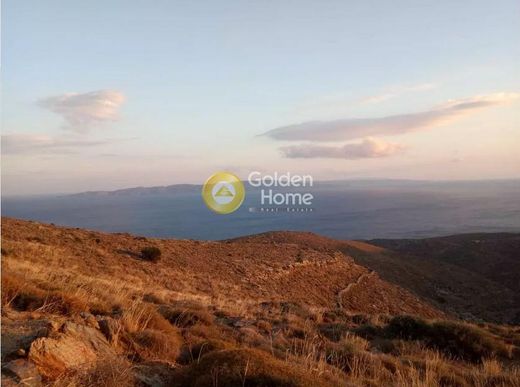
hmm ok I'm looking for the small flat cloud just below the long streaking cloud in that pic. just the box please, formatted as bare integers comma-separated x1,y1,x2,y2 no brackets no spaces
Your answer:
280,137,404,160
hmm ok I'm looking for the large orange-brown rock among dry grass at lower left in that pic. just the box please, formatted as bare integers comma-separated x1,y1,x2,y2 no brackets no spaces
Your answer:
29,322,113,379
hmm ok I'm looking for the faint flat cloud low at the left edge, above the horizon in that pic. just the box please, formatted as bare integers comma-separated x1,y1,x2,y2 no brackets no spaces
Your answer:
2,134,110,154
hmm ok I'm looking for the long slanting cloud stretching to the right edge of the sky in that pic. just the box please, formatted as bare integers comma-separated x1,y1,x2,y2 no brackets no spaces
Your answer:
263,93,520,141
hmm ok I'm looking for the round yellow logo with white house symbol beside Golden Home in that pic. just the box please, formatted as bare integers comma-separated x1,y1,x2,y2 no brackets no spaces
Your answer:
202,172,246,214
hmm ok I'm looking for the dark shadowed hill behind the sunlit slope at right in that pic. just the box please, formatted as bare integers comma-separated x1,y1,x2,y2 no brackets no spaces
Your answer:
237,231,520,324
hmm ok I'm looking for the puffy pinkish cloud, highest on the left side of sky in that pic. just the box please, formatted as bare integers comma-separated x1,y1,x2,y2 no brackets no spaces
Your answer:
38,90,125,133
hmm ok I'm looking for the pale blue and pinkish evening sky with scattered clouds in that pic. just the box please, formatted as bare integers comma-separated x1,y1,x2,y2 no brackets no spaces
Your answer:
1,0,520,195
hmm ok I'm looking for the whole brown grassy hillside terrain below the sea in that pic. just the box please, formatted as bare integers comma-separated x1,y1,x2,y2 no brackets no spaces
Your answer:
2,218,520,386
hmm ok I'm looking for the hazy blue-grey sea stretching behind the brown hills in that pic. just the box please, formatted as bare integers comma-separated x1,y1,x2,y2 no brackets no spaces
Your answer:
2,180,520,239
